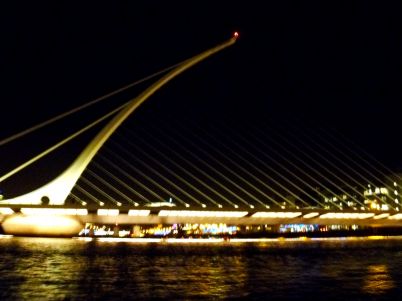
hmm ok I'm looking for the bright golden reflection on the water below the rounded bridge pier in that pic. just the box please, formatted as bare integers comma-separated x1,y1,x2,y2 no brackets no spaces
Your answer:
0,238,85,300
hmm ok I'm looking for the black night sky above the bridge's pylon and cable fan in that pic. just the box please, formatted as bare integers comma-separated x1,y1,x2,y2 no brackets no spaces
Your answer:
0,1,402,202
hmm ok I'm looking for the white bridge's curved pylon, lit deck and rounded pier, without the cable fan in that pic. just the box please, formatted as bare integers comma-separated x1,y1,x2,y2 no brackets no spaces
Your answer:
0,34,402,236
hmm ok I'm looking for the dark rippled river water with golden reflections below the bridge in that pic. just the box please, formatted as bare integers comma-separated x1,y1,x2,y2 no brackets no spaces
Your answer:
0,237,402,300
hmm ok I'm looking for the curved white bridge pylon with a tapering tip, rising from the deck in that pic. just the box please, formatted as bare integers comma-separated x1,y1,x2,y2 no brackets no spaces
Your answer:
0,36,236,205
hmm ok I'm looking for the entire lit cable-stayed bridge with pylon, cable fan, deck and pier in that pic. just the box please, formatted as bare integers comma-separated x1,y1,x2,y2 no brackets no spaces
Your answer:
0,34,402,235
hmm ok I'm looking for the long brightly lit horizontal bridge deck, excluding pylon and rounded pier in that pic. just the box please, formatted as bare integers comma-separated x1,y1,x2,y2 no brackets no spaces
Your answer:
0,205,402,226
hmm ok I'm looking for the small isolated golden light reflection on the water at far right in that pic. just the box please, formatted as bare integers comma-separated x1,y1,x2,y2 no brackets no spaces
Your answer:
362,264,395,295
